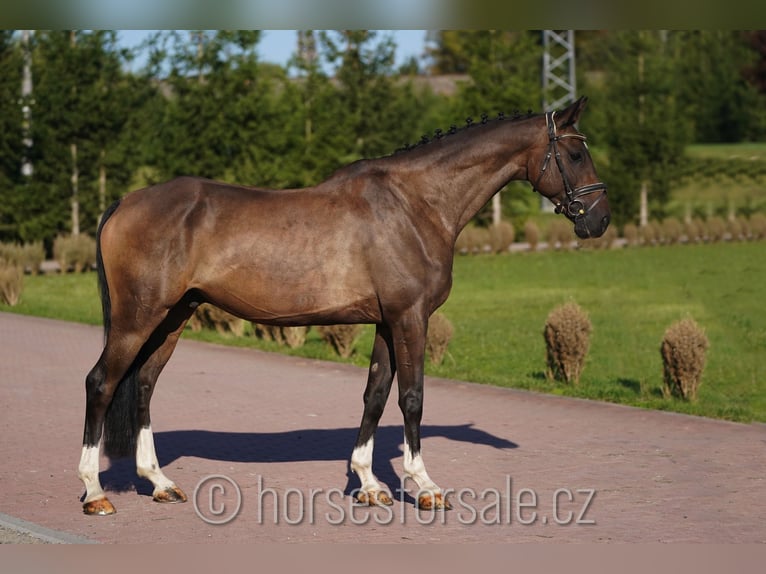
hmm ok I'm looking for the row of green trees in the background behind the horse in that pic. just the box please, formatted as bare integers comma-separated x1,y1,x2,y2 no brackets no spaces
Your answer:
0,30,766,247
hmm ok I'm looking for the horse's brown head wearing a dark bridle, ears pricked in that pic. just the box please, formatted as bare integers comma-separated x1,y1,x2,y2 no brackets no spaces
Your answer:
528,98,610,239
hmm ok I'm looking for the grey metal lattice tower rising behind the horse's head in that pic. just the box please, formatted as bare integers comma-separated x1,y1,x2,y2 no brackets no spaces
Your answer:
541,30,577,212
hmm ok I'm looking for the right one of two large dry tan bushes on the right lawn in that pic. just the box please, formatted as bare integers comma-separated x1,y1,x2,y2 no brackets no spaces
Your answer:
660,319,709,401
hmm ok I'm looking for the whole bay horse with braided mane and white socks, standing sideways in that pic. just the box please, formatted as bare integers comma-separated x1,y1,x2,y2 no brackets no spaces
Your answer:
78,98,609,515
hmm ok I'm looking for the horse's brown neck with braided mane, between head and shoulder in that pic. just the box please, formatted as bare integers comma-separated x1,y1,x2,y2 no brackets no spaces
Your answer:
402,120,540,240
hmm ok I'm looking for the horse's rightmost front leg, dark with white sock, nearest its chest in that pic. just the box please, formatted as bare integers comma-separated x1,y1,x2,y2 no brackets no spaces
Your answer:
392,313,452,510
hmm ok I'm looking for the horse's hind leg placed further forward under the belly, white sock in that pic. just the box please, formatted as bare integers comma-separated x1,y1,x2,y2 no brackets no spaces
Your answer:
136,300,193,502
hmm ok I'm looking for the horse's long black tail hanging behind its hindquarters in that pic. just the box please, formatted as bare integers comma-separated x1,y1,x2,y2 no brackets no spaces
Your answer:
96,200,138,458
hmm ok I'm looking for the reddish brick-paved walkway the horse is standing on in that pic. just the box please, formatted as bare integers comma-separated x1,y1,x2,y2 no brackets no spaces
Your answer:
0,313,766,543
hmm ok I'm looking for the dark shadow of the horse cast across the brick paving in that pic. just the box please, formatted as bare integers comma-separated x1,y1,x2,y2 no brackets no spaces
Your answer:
101,423,518,501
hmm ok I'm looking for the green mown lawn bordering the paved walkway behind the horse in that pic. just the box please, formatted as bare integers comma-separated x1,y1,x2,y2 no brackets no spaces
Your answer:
6,238,766,422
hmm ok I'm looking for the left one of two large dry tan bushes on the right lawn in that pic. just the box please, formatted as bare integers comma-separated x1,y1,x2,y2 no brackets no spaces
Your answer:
543,302,592,384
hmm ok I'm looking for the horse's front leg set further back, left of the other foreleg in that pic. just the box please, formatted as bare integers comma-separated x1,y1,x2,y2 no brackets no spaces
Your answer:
351,325,396,506
